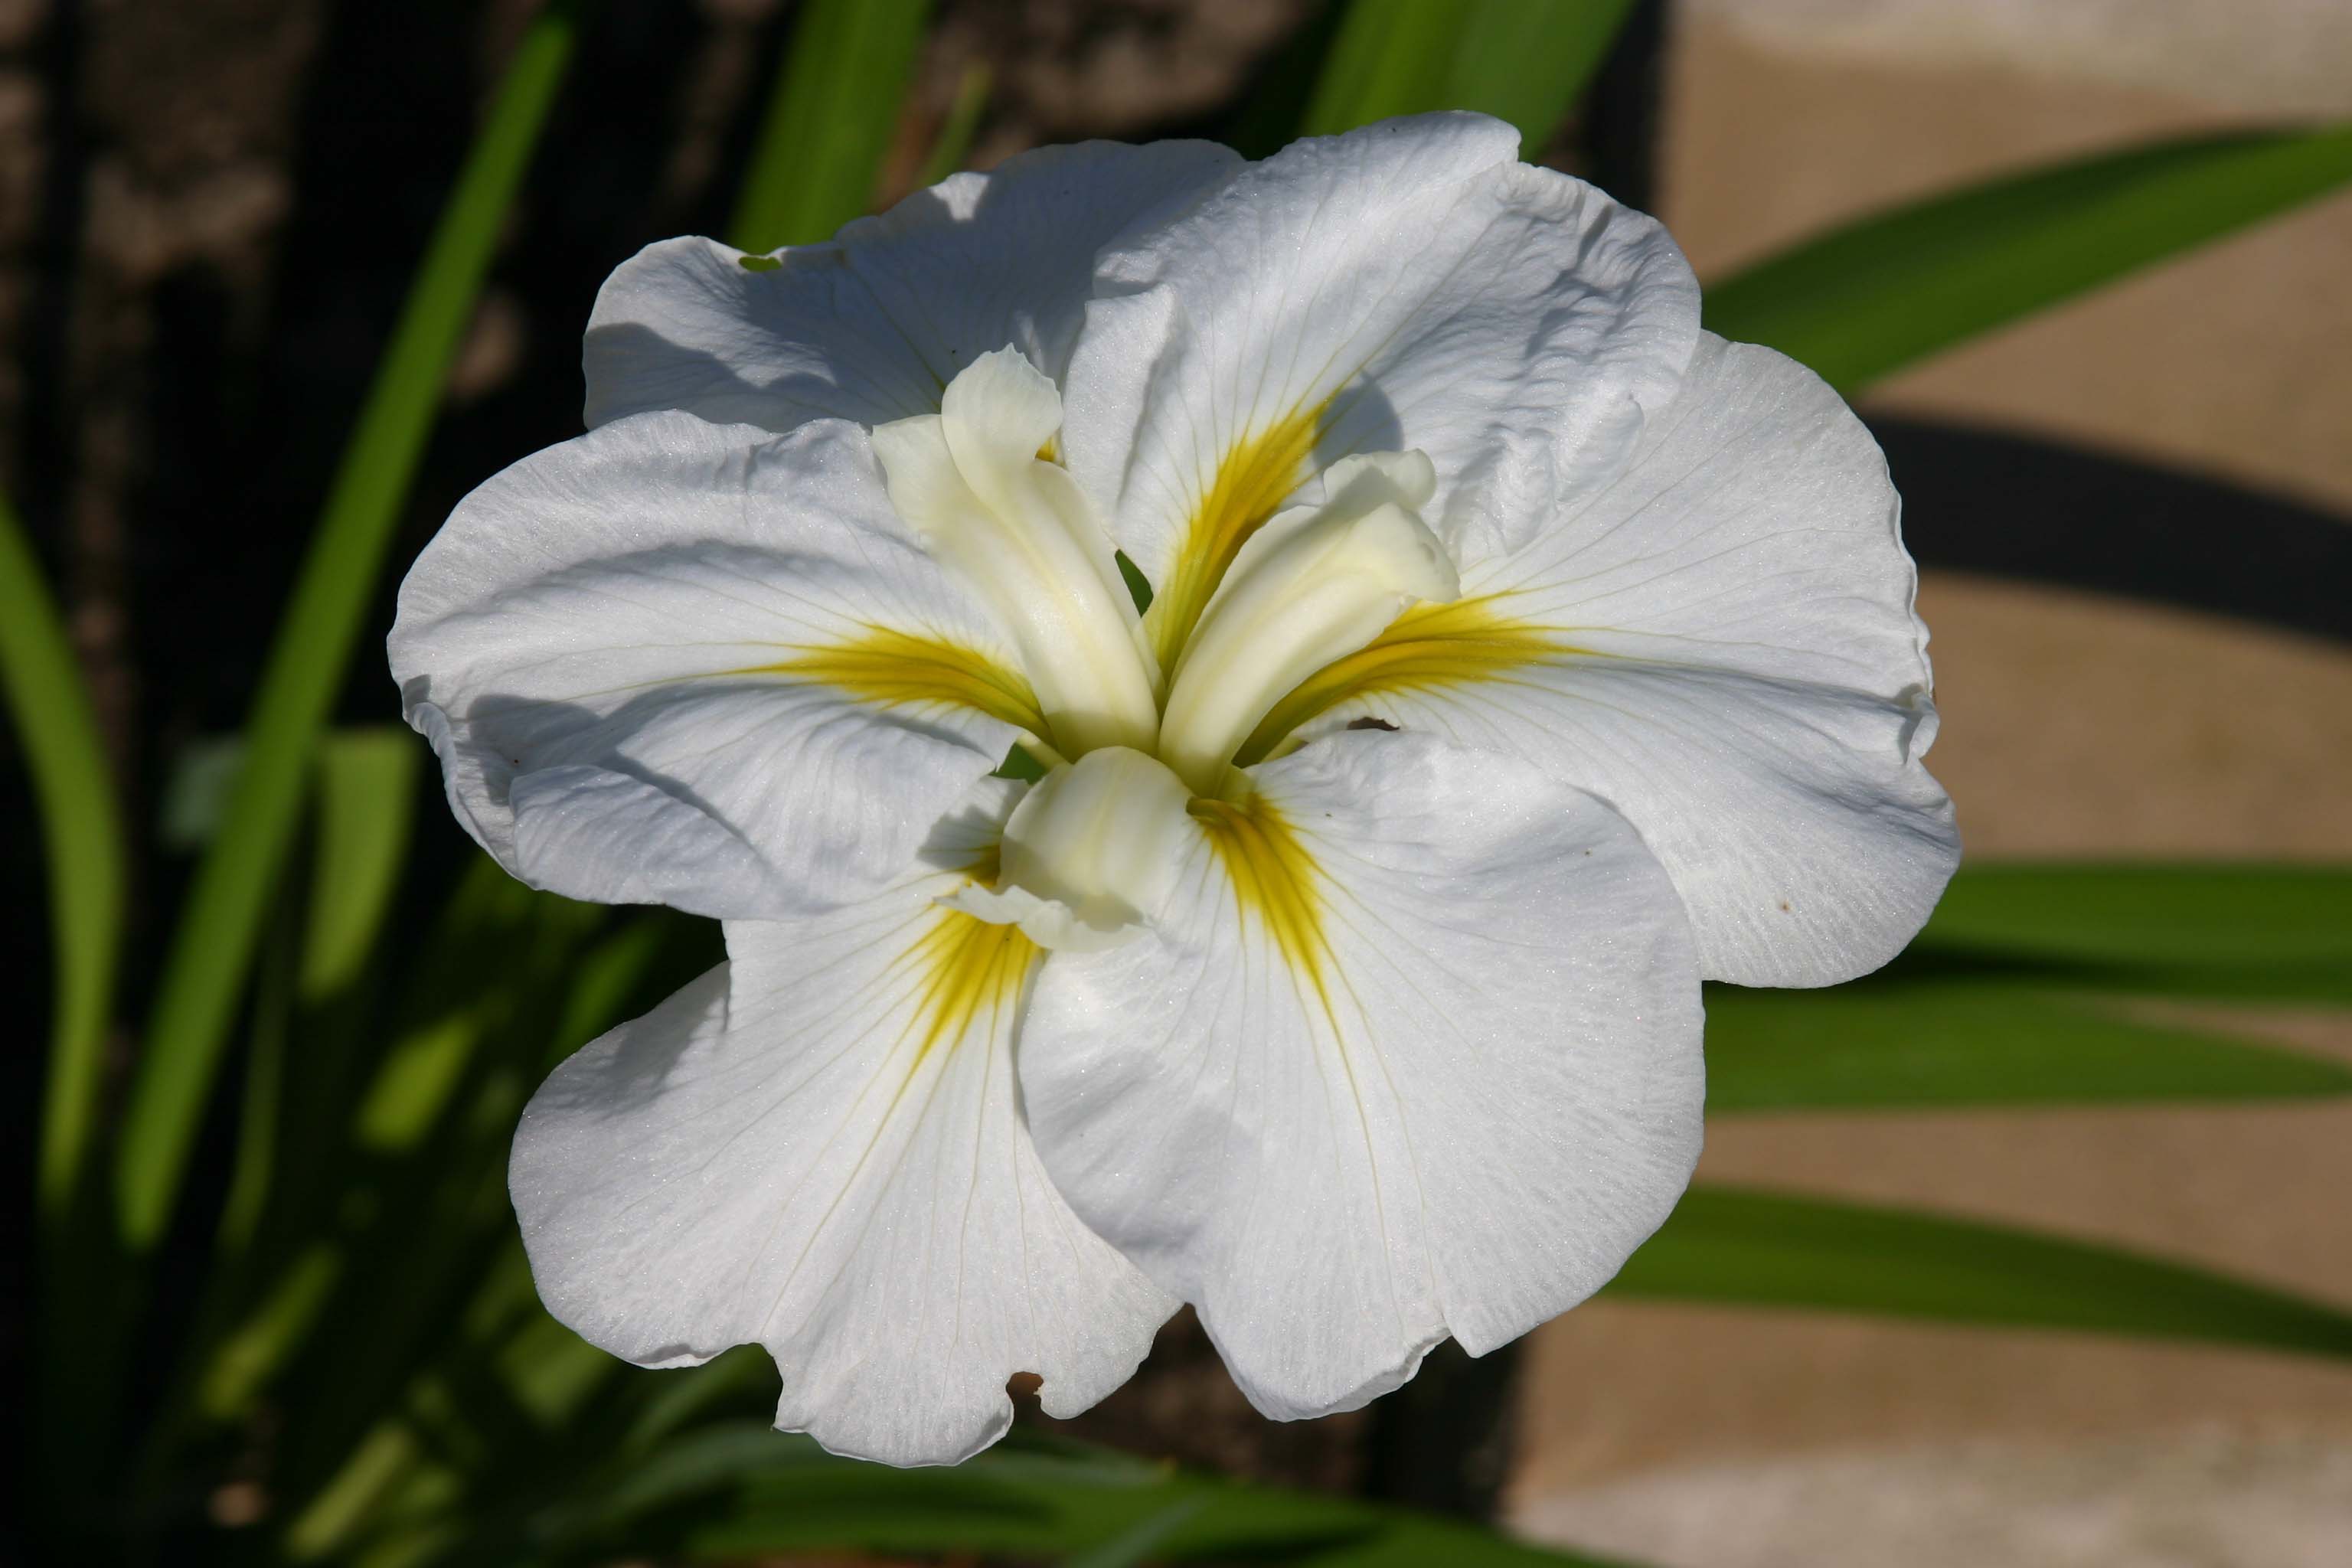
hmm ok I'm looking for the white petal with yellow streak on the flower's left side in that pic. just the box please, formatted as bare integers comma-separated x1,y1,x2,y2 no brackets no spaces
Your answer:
390,413,1025,916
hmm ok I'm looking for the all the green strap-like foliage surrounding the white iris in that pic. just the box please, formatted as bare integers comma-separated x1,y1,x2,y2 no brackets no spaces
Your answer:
14,0,2352,1568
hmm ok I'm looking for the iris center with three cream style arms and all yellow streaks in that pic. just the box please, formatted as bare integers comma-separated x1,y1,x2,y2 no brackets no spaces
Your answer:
846,350,1569,959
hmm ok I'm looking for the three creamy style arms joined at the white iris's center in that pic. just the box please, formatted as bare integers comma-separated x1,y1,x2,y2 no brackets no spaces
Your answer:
873,348,1461,947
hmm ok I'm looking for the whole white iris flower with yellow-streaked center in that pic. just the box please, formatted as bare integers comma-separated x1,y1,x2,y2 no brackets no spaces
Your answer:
393,115,1957,1465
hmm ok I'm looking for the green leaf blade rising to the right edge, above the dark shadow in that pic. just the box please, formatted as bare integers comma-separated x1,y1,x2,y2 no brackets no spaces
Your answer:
1705,127,2352,395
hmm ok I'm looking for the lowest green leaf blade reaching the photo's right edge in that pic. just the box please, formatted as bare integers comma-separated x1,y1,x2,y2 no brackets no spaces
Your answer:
1609,1185,2352,1357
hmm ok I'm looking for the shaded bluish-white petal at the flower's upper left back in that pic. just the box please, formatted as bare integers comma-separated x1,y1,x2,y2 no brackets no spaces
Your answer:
583,141,1240,430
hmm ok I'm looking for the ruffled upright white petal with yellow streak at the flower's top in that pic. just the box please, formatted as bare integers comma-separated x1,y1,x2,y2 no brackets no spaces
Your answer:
1063,115,1698,654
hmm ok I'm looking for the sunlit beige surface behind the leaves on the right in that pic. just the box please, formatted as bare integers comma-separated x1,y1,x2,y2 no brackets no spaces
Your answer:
1512,0,2352,1568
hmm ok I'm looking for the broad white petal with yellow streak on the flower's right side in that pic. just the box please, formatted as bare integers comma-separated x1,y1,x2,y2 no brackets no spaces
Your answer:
1269,334,1959,985
